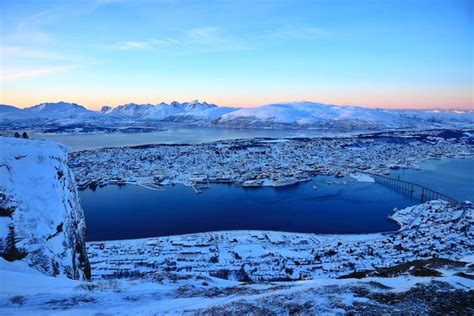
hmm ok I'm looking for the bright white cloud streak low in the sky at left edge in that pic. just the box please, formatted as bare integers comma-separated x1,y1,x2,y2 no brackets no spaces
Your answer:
1,65,80,81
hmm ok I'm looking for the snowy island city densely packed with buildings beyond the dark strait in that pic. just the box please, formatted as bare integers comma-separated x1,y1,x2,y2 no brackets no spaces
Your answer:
70,131,474,189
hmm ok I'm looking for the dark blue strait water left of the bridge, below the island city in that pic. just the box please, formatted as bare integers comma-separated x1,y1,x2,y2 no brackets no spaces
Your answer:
80,177,417,240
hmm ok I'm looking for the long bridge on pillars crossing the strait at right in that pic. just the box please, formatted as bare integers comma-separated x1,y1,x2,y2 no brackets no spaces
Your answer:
367,172,460,204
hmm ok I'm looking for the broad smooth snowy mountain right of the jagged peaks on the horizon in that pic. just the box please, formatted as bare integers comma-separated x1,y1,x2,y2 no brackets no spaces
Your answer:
218,102,474,128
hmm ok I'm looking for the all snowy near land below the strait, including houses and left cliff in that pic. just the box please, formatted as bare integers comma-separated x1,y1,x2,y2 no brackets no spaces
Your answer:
0,138,474,315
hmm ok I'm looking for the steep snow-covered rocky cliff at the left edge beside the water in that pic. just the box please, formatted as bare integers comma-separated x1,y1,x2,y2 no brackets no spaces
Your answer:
0,137,90,279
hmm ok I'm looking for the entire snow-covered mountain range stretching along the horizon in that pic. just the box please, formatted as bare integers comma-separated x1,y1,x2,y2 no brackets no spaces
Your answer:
0,101,474,129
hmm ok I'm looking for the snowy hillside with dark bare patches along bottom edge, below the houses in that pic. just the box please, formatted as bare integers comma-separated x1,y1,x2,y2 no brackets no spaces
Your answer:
0,249,474,315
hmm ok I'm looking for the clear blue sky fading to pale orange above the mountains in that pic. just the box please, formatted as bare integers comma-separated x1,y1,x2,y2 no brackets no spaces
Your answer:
0,0,474,109
